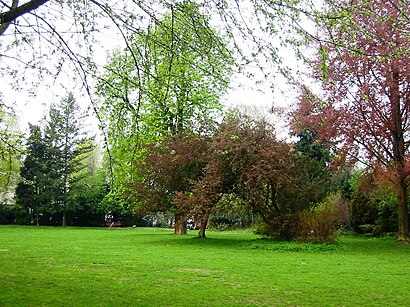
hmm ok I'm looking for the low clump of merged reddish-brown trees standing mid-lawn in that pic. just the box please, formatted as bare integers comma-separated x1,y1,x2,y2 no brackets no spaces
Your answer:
123,116,329,239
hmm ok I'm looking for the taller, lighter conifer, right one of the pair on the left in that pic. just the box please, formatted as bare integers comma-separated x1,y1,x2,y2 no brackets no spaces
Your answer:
45,93,94,226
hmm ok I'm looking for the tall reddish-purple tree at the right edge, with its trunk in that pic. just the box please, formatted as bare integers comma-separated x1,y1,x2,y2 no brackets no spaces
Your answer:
293,0,410,242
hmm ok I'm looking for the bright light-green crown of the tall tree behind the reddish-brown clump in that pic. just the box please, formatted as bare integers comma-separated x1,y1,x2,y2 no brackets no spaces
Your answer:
98,1,232,180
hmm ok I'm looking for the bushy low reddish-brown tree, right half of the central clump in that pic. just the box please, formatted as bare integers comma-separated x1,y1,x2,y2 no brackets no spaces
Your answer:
213,116,330,239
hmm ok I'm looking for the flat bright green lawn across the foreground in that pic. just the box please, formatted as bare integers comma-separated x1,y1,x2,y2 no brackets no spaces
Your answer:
0,226,410,306
